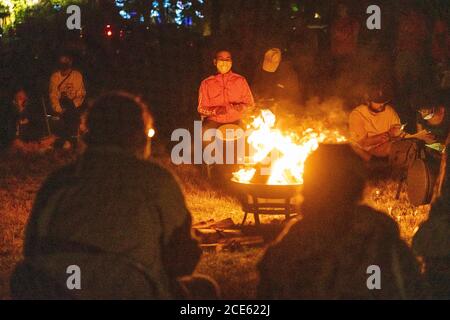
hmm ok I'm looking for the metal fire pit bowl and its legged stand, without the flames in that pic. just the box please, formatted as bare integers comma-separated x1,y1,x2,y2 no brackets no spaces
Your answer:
231,178,302,225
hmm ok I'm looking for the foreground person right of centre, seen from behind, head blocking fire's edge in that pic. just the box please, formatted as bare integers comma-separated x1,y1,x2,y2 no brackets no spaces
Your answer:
258,145,424,300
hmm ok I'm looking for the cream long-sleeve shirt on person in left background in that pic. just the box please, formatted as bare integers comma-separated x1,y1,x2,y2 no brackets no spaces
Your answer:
49,70,86,113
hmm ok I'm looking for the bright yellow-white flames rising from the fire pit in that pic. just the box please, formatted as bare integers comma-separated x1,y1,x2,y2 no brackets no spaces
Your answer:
233,110,346,185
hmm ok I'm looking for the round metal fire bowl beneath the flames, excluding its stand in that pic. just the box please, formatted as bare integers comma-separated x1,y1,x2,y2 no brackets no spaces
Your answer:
231,178,303,199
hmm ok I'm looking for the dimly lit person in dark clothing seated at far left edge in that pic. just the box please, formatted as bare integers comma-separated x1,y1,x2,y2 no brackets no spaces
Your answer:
0,88,54,152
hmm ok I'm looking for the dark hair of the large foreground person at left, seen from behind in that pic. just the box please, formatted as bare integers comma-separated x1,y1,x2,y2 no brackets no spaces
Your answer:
85,91,149,151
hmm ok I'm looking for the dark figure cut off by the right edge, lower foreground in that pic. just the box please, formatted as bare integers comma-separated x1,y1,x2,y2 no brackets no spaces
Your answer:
413,135,450,300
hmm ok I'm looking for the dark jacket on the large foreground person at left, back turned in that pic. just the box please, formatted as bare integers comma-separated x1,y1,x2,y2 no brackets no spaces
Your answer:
16,148,200,299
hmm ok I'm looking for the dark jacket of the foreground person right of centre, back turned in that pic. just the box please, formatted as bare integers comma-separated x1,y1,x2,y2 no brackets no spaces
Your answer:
258,206,423,299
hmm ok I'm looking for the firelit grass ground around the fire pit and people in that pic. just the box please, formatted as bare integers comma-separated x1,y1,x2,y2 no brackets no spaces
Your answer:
0,150,429,299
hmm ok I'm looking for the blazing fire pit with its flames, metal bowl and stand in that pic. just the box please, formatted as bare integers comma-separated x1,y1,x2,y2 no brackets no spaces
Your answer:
231,109,345,224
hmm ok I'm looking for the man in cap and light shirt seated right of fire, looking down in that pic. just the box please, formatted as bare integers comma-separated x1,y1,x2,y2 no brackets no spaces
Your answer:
349,86,430,161
